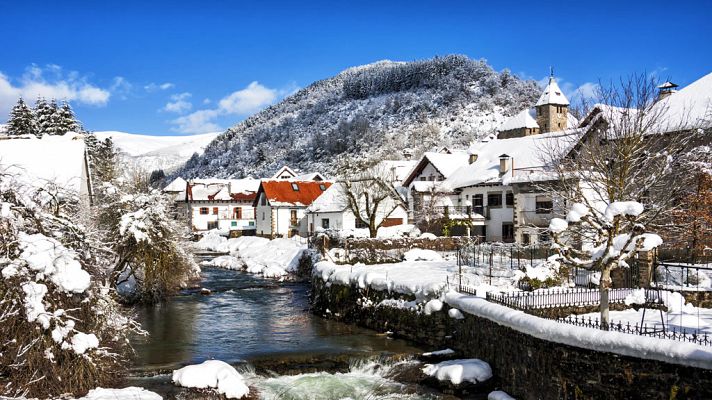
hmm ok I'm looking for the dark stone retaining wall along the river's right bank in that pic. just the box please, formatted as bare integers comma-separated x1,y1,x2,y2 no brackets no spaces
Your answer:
311,278,712,400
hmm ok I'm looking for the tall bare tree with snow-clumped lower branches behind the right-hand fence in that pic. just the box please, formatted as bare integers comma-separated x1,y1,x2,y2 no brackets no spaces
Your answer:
547,74,698,328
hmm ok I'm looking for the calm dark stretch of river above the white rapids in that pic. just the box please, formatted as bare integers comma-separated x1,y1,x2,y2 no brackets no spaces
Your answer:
134,269,419,370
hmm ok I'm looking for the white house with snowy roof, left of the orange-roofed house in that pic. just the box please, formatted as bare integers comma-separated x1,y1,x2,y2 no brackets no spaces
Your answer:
184,178,260,236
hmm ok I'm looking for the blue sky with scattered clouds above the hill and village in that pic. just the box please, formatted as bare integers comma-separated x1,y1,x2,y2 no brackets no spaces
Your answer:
0,0,712,134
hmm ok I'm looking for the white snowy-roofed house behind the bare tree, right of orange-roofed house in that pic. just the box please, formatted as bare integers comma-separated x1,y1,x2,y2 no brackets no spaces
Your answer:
307,183,408,234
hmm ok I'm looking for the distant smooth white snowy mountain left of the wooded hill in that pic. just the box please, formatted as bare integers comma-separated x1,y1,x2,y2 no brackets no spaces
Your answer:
95,131,219,172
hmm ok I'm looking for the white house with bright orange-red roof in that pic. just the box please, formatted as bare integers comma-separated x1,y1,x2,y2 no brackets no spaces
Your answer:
254,179,331,238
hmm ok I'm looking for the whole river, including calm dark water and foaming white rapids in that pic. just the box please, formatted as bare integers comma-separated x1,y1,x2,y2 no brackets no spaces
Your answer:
129,268,450,399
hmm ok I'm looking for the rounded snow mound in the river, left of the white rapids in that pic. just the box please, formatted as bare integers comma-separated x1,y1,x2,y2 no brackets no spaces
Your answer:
172,360,250,399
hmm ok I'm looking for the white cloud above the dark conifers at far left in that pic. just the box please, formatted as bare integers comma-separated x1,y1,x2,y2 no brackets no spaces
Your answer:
0,64,112,118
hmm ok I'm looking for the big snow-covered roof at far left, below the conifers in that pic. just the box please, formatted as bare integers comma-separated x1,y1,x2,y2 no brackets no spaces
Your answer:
0,133,87,194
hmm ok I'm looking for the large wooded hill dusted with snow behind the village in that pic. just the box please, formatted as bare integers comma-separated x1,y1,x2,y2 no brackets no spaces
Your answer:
178,56,540,178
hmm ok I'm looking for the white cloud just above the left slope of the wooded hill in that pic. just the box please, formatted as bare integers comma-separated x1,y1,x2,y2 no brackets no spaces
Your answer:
171,81,298,133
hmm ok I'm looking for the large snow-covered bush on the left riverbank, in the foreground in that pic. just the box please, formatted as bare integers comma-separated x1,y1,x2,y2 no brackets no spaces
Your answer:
0,173,139,398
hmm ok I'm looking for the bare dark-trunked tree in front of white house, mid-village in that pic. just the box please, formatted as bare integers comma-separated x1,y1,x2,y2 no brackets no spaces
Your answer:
338,163,404,238
